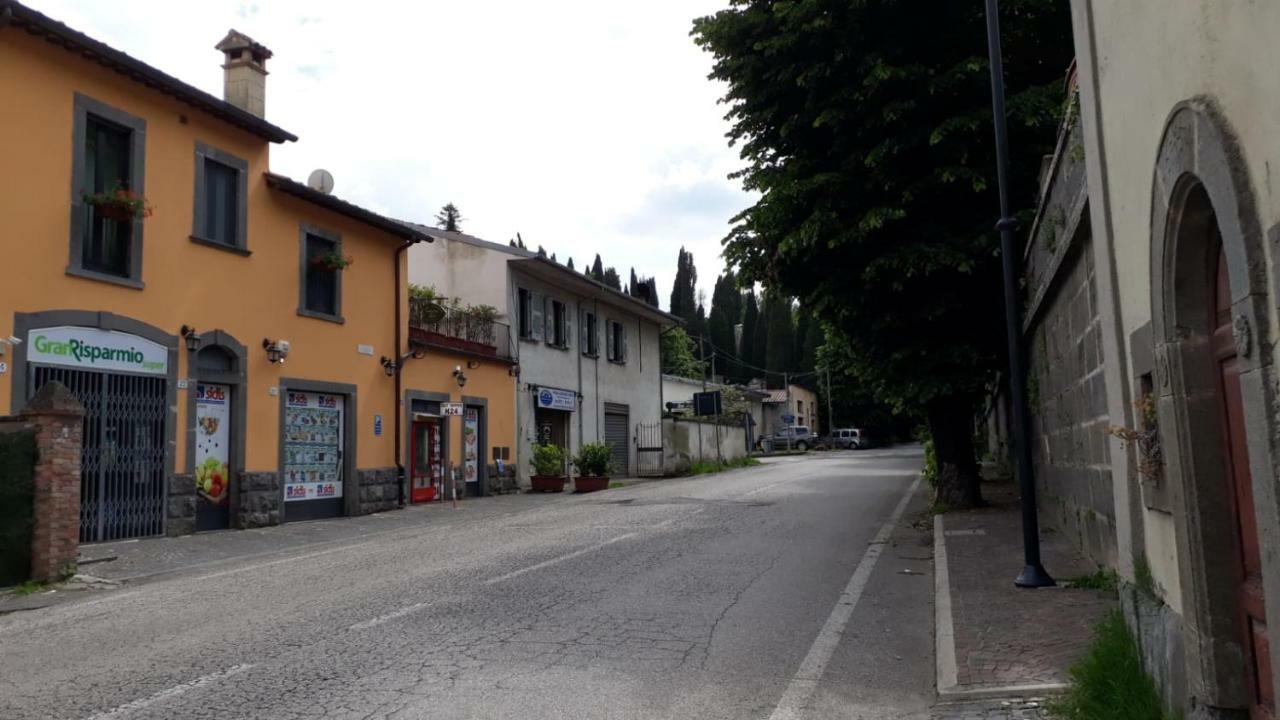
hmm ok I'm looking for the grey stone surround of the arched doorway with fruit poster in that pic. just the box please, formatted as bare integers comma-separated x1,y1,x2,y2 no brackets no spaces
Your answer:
183,329,248,528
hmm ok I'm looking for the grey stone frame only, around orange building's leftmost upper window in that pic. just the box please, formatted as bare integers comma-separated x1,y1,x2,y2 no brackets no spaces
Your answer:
67,92,147,290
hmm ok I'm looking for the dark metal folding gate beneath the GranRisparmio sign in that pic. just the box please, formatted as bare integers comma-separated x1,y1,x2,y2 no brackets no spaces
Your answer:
31,365,166,542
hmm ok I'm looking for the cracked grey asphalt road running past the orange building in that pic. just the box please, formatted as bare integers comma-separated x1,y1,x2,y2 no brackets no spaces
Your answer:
0,447,933,720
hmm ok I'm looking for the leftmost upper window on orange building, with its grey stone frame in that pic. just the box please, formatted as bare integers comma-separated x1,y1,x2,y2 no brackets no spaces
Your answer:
67,95,146,288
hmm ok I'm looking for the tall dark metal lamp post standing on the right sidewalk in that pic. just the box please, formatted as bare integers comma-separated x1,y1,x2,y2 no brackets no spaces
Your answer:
987,0,1055,588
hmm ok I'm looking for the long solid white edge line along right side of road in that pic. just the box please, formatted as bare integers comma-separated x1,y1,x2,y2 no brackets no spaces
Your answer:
769,477,920,720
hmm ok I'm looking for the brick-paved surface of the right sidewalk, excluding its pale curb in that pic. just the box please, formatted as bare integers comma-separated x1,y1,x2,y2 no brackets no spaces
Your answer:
943,483,1115,691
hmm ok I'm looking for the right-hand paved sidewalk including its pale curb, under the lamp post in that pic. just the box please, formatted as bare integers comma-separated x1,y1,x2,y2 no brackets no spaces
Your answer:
933,480,1115,720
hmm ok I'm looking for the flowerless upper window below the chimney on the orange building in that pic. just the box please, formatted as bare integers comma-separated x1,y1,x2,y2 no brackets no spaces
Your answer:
191,142,248,254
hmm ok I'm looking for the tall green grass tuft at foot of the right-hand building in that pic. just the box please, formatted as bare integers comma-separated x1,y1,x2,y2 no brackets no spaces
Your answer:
1050,610,1170,720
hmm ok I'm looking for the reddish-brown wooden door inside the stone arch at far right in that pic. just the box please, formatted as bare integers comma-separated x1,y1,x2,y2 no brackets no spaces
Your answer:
1212,244,1275,720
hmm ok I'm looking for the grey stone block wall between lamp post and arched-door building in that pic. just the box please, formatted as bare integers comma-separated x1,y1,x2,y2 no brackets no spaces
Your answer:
1028,232,1117,566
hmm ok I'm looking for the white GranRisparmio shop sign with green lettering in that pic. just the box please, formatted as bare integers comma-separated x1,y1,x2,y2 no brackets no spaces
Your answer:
27,325,169,375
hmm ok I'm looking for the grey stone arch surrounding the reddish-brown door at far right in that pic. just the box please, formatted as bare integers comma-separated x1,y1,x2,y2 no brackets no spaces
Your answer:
1151,97,1280,716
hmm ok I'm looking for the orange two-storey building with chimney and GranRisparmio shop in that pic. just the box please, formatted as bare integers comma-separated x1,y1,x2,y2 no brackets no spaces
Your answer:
0,0,515,542
